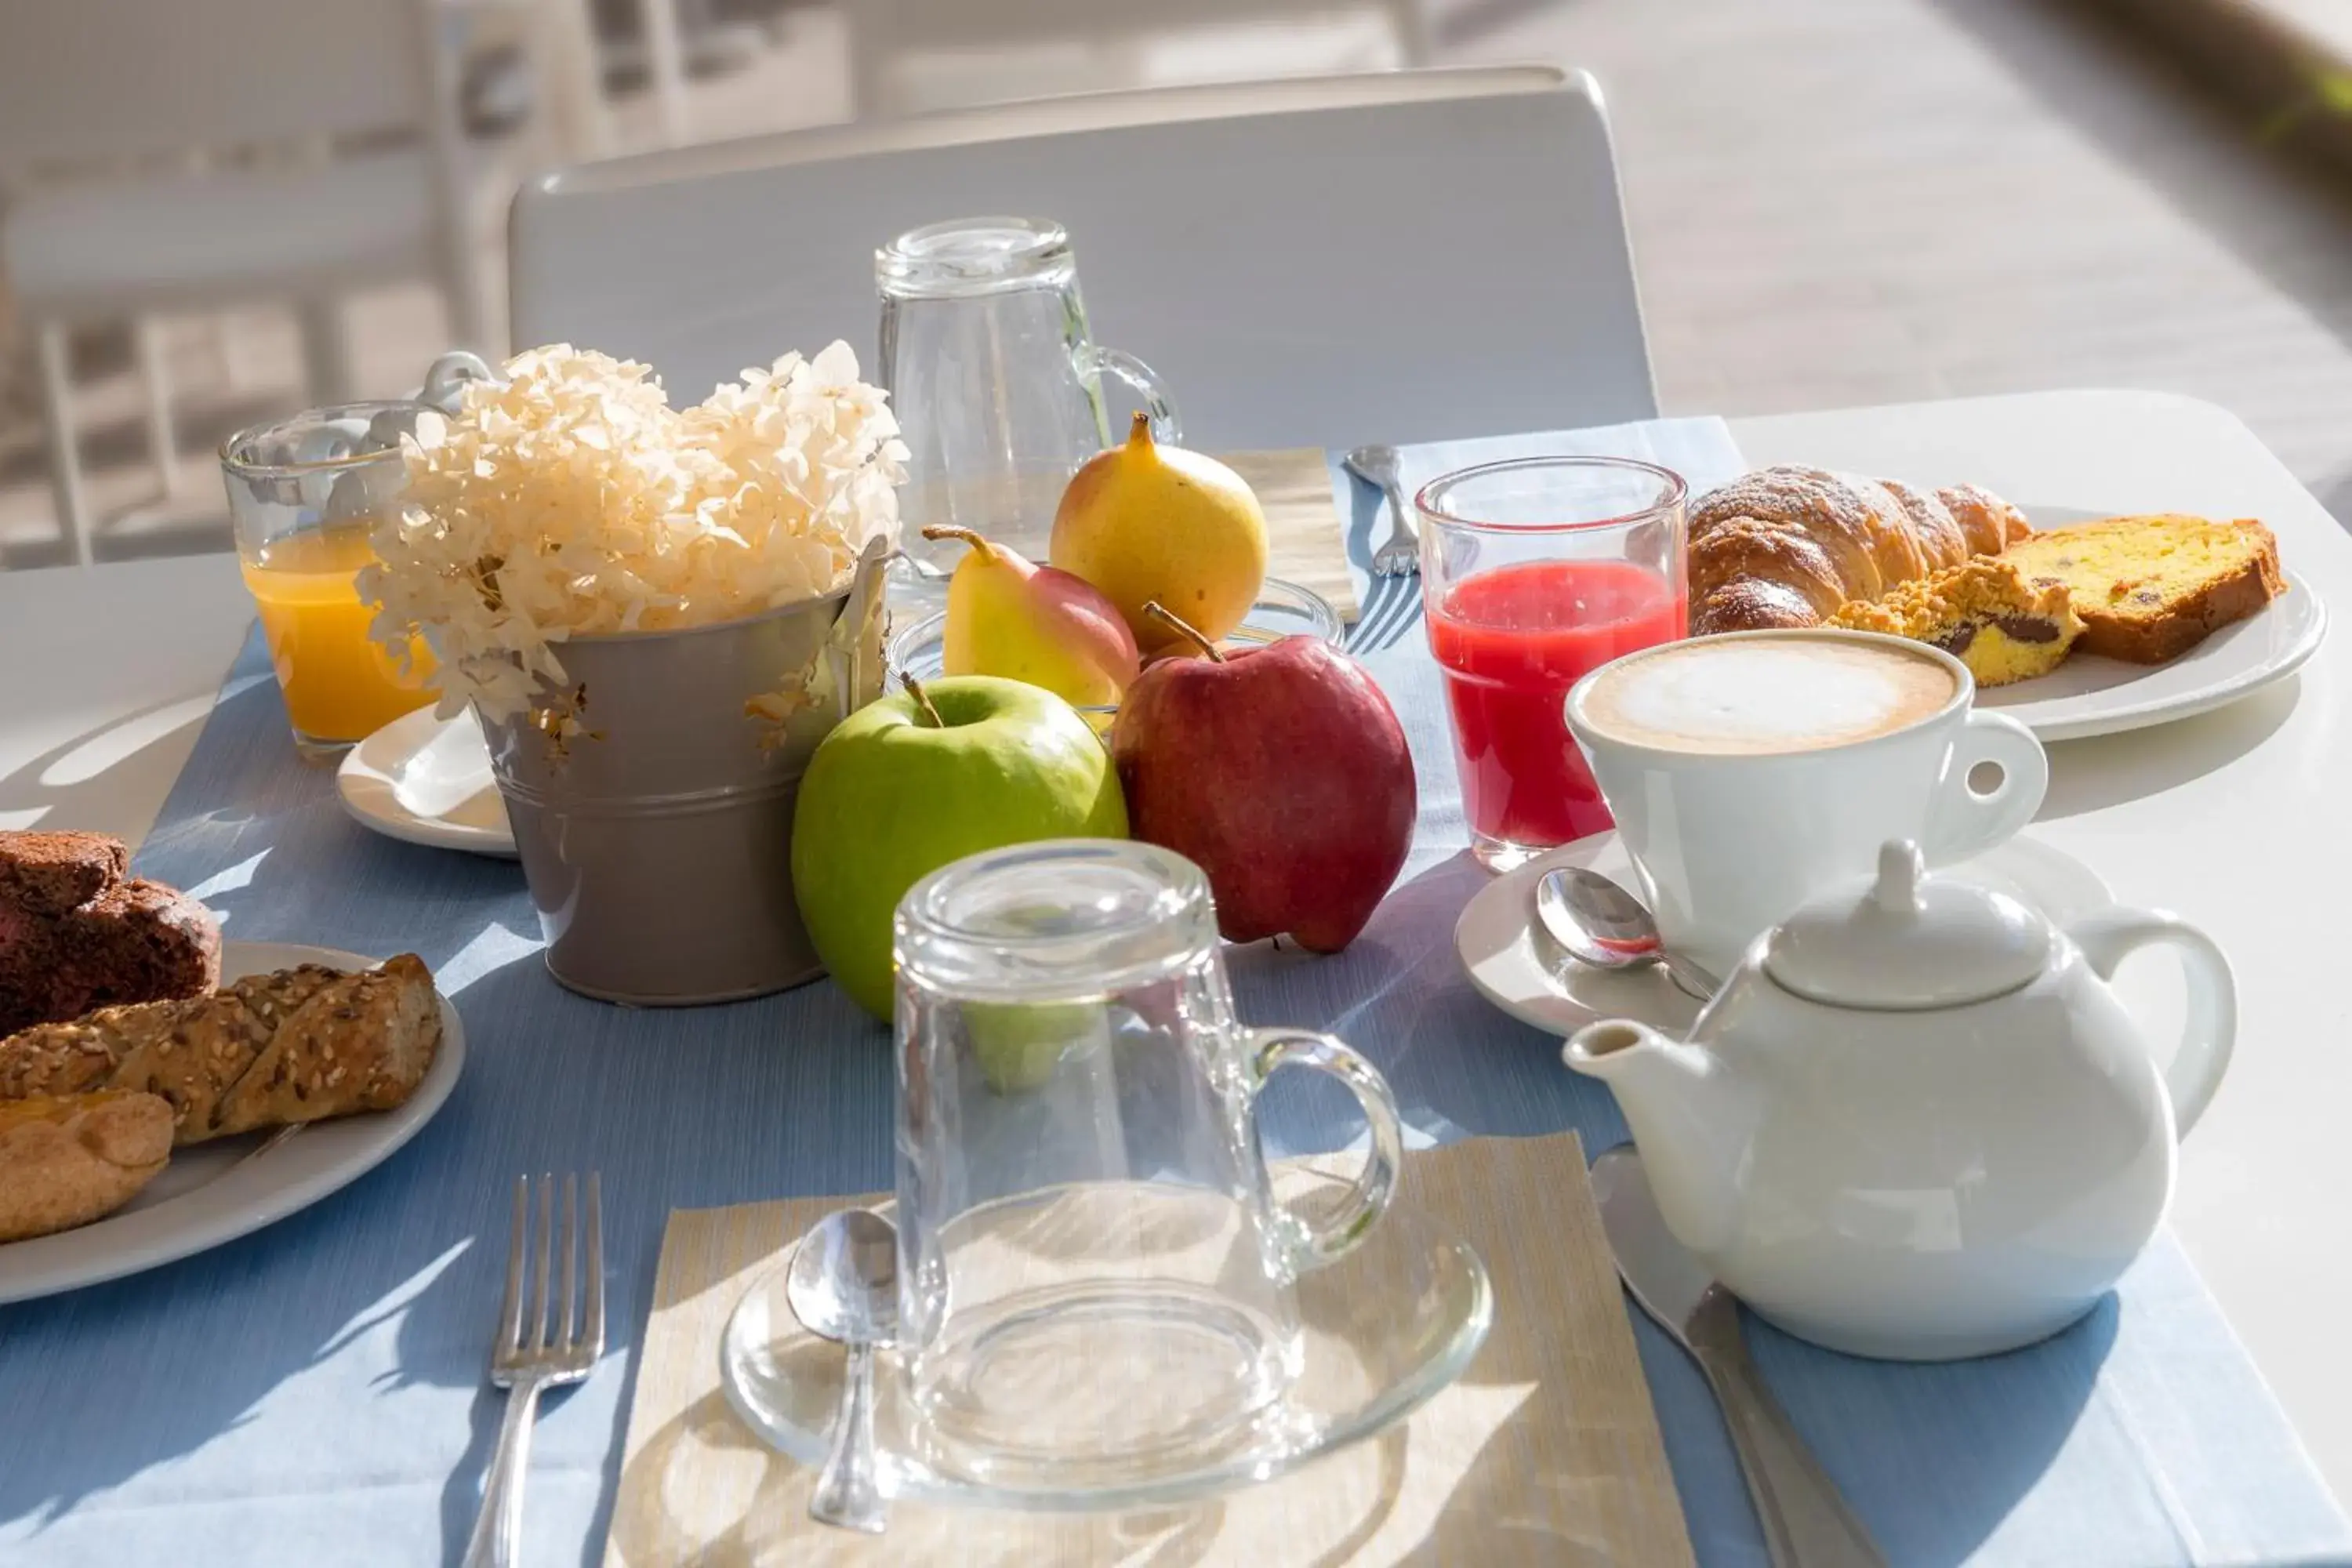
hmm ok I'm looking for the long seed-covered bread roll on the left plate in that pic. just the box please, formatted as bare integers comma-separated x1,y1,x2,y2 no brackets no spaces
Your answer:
0,954,442,1145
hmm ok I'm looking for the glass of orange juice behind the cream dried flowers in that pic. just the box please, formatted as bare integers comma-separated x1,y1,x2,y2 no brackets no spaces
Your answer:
221,402,437,760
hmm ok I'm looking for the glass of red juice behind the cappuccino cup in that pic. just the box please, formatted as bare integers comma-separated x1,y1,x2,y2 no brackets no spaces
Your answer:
1416,459,1689,872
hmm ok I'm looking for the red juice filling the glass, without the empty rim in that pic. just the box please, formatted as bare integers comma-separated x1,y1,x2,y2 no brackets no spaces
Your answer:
1428,560,1686,848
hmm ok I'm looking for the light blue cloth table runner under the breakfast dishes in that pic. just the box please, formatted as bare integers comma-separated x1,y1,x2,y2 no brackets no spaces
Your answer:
0,421,2352,1568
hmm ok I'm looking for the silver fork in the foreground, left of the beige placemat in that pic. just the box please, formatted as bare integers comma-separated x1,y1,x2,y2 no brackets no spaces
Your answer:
466,1171,604,1568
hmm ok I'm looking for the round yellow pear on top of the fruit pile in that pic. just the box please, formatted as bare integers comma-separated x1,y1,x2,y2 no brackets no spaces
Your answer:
1051,414,1265,654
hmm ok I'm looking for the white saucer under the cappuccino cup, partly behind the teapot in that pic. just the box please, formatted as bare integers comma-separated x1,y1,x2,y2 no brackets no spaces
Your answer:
1454,832,2114,1036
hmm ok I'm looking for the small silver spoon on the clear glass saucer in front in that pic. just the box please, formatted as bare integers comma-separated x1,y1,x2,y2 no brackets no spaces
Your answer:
783,1208,898,1535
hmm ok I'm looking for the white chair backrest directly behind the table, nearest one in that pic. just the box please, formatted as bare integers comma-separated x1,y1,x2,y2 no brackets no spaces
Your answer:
508,66,1656,449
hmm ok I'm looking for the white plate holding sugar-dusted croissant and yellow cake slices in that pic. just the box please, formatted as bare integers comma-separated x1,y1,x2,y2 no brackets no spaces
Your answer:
1689,468,2326,741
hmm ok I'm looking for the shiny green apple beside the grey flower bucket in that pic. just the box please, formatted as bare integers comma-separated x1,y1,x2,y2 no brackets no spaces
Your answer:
793,675,1127,1022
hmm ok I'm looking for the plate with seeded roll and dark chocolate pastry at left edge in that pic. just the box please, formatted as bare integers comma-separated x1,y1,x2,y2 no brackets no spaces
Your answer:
0,832,466,1302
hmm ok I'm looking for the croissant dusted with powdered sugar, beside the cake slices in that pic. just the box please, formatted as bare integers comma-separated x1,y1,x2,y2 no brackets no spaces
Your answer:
1689,468,2032,637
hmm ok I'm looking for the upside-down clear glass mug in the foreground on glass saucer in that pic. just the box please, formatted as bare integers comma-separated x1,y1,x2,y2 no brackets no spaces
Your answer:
896,839,1402,1488
